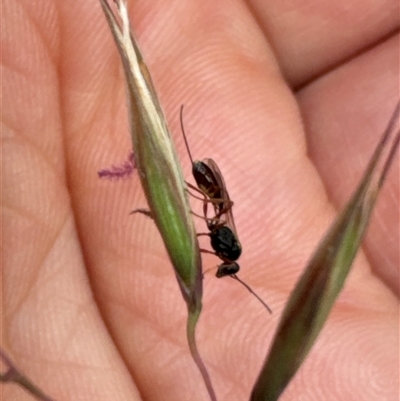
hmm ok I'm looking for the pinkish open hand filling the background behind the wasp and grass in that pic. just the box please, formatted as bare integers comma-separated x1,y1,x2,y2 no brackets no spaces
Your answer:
2,0,399,401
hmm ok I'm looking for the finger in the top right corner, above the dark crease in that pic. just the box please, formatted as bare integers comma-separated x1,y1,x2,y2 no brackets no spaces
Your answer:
250,0,399,87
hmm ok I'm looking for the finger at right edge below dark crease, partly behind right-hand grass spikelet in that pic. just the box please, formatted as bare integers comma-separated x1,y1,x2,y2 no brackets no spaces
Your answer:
299,35,399,295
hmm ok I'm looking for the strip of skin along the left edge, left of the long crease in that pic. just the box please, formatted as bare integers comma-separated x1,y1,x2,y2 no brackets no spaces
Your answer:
2,1,141,401
